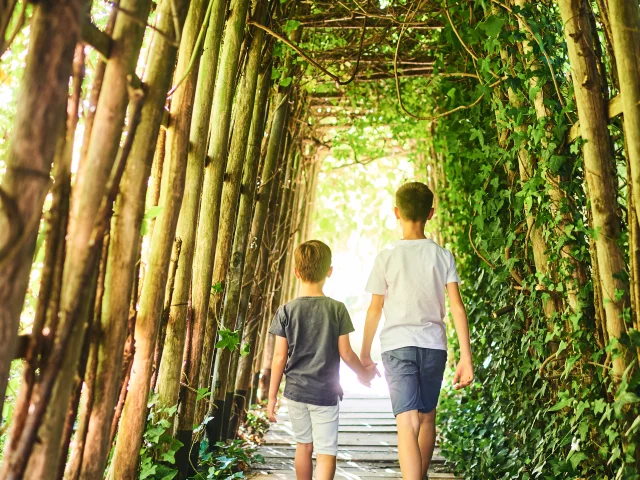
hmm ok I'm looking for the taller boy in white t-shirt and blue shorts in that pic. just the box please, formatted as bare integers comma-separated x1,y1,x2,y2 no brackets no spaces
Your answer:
360,182,473,480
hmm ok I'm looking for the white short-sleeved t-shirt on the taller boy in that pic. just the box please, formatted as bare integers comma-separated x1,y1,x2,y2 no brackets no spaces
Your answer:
366,239,460,352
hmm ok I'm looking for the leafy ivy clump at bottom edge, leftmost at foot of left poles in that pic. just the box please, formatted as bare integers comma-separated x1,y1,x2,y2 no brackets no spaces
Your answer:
140,394,183,480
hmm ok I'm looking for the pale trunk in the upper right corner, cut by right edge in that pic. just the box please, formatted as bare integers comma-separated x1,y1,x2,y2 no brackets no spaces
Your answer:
607,0,640,229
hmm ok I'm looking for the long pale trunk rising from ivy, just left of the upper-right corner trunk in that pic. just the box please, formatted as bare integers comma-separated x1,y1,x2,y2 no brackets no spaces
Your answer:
558,0,629,379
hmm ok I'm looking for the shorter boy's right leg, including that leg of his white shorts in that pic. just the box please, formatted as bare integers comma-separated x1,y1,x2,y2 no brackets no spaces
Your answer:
309,405,340,480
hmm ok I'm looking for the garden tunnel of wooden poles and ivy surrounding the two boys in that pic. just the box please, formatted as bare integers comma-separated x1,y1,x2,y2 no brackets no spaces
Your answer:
0,0,640,480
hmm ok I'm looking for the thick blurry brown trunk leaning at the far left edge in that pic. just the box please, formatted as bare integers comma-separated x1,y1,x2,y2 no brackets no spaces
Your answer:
0,0,84,422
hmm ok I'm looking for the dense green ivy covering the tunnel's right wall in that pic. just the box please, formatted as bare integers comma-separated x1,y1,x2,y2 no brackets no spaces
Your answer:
420,4,640,479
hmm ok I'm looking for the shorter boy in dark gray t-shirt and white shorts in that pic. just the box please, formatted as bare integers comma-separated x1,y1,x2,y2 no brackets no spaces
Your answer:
267,240,377,480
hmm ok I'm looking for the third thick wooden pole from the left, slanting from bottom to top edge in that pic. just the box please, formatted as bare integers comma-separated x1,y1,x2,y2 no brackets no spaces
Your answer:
75,2,192,479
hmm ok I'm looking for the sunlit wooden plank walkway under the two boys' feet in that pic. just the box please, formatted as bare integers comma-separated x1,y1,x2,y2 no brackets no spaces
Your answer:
252,379,459,480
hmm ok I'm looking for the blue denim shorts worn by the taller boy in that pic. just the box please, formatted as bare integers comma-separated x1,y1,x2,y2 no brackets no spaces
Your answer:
382,347,447,415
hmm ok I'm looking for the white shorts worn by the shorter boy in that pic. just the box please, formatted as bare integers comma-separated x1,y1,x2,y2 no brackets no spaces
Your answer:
287,399,340,457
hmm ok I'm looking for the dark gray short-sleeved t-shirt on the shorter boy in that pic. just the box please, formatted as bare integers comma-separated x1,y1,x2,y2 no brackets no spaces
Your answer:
269,297,354,406
